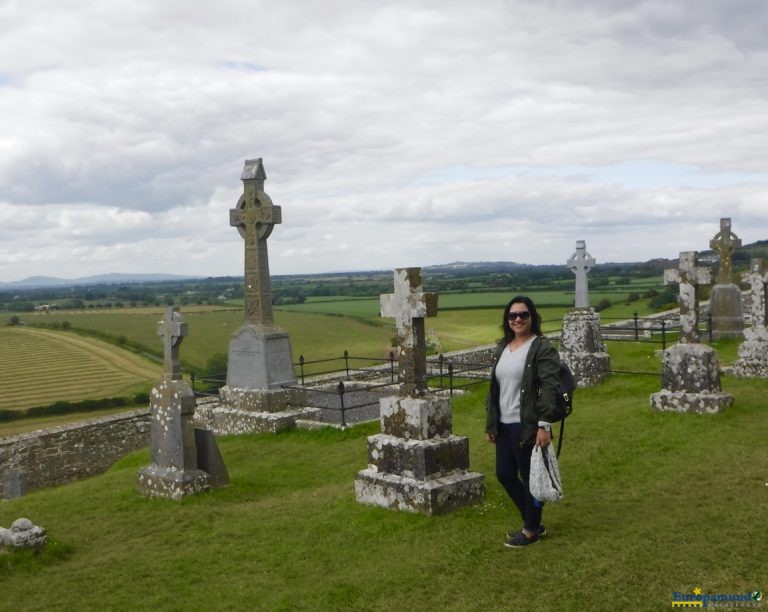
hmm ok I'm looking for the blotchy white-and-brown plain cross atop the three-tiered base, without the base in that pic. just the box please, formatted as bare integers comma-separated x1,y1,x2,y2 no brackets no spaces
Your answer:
380,268,437,397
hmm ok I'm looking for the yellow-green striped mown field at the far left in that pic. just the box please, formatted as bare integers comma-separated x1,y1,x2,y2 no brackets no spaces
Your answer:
0,327,157,410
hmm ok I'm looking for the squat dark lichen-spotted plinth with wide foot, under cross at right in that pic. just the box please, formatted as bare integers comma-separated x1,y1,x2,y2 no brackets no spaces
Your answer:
651,344,733,414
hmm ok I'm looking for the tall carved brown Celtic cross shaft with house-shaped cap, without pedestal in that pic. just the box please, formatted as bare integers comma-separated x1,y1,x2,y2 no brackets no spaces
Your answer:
229,158,282,327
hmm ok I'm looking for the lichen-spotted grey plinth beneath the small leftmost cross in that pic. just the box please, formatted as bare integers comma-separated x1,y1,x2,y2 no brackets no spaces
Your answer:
136,378,229,500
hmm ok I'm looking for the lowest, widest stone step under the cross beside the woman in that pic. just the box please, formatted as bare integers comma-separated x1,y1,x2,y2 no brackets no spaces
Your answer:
355,468,485,516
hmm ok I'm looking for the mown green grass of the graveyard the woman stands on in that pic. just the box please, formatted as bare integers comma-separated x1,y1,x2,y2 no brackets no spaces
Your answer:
0,344,768,610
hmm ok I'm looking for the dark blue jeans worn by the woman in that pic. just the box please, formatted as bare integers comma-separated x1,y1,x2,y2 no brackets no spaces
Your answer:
496,423,544,533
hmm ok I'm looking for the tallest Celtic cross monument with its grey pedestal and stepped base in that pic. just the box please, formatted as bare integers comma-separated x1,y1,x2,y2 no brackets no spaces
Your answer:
198,158,304,433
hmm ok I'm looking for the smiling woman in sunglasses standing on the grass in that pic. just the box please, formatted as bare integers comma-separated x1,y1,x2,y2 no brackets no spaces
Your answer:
485,295,560,548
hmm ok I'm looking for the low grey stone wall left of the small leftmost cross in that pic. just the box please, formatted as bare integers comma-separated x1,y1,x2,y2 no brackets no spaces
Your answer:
0,409,149,499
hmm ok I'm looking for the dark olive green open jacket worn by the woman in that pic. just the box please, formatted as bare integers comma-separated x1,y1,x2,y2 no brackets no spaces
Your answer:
485,336,560,446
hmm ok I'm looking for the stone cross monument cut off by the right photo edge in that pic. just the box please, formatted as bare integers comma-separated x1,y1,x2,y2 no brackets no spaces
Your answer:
733,259,768,378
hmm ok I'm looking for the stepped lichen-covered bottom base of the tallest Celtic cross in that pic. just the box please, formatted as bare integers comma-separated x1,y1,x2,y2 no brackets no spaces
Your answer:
195,386,316,435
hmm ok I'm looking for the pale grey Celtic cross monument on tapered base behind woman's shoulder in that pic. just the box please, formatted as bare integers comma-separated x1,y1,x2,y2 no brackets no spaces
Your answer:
560,240,611,387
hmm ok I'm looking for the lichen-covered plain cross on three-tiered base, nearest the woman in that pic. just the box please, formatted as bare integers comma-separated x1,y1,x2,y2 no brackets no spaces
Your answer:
355,268,485,516
